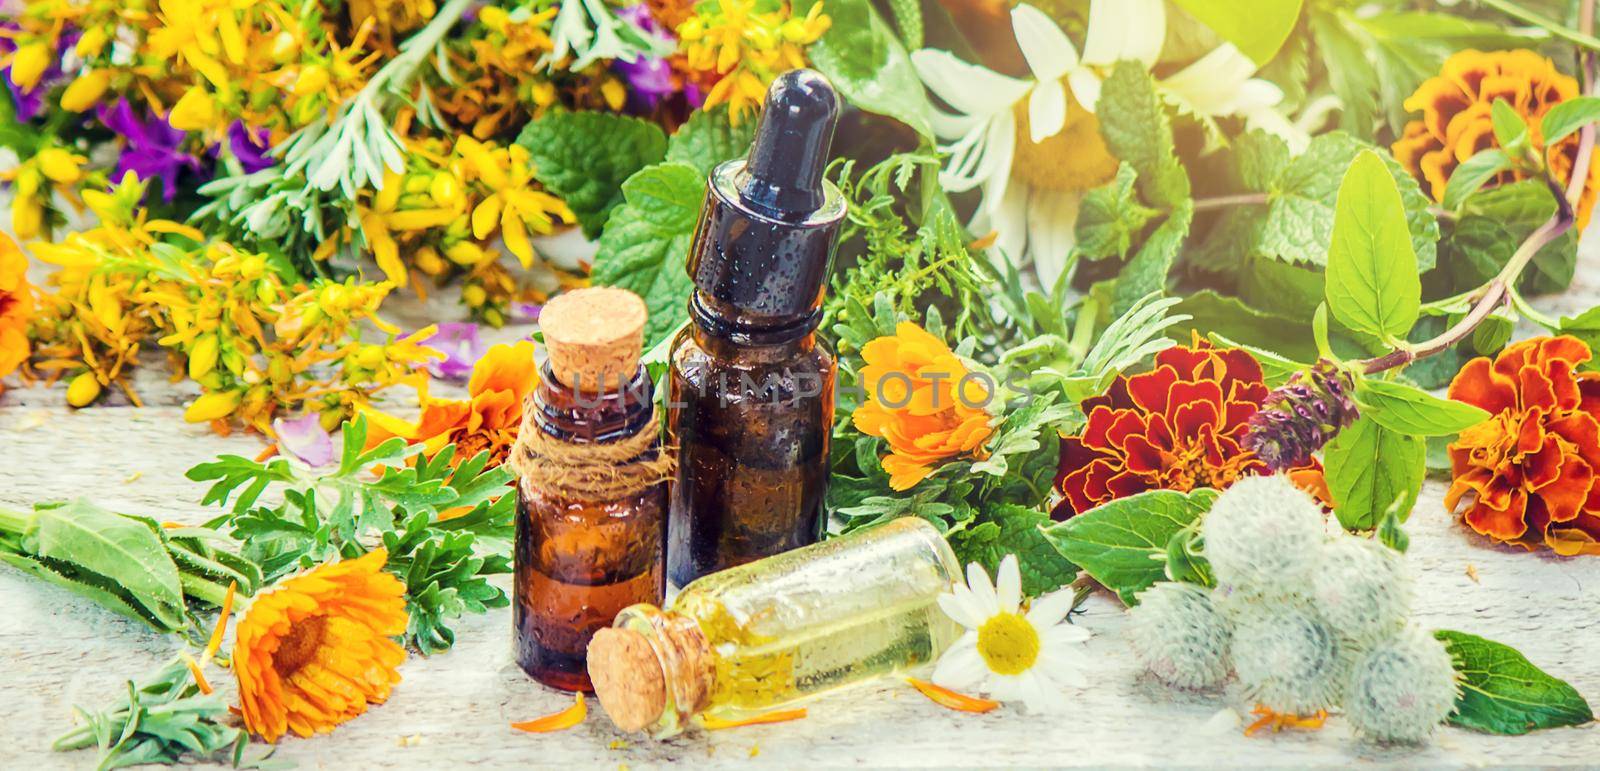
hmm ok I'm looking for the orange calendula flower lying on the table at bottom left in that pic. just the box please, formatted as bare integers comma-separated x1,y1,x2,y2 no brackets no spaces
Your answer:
234,549,406,742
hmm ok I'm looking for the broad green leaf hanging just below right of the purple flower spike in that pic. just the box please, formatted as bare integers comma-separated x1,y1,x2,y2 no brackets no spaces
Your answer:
1322,414,1427,529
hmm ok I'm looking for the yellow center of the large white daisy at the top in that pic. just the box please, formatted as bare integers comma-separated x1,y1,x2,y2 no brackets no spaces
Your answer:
1011,85,1117,190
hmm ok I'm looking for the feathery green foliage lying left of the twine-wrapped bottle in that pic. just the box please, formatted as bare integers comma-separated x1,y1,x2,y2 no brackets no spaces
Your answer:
189,417,515,654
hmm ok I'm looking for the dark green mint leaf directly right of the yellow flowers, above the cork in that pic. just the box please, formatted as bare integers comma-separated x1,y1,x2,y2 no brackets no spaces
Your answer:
517,110,667,238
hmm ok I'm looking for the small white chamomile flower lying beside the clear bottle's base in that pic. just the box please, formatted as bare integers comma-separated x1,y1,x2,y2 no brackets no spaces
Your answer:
933,555,1090,712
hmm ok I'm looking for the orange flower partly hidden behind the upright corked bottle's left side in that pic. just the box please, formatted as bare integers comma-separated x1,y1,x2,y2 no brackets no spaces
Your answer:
365,341,539,465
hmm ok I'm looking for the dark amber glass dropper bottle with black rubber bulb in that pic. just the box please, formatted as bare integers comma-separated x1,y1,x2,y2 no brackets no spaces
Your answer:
667,70,845,585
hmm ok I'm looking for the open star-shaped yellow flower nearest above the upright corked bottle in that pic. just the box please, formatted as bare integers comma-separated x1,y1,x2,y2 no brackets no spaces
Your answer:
456,136,578,267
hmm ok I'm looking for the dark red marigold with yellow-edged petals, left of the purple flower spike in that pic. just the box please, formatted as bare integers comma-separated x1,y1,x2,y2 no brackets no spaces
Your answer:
1054,341,1280,520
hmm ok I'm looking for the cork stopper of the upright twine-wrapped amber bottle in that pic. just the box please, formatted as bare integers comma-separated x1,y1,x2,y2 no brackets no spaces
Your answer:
539,286,648,393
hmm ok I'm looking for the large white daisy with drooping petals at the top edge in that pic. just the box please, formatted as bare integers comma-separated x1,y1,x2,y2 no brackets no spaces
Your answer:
912,0,1296,290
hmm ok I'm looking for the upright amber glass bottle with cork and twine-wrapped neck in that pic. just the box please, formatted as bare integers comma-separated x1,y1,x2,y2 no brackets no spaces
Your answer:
512,288,672,691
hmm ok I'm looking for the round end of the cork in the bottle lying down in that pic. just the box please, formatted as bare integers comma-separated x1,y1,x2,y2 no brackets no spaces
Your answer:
589,629,667,731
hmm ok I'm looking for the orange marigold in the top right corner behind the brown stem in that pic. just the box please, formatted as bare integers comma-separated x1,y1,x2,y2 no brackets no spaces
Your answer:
1392,50,1600,229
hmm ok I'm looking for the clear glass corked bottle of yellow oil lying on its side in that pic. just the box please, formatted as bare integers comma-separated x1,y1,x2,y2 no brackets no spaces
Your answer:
589,517,962,737
